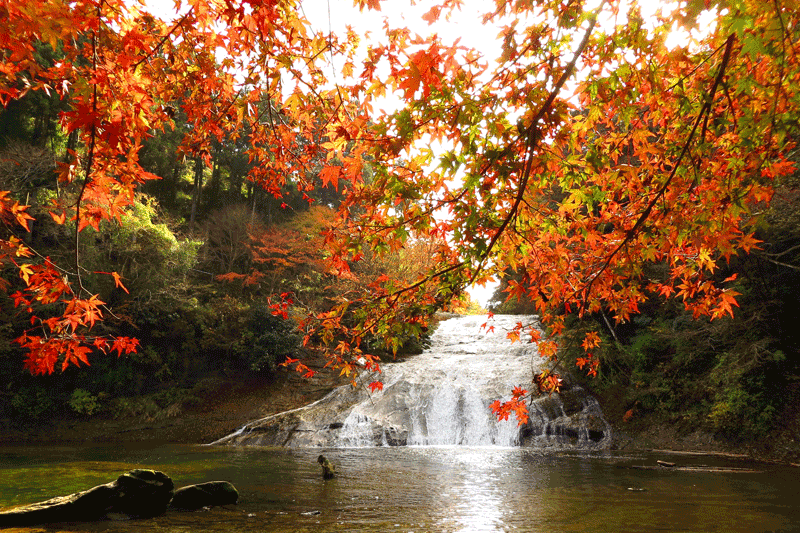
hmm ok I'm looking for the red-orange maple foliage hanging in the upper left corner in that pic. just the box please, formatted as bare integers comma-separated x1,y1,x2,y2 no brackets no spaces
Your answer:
0,0,354,373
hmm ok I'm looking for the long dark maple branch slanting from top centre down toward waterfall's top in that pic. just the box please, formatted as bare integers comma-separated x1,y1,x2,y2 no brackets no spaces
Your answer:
469,6,606,284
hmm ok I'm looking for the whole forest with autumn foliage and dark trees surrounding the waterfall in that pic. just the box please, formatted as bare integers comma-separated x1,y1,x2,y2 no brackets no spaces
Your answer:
0,0,800,442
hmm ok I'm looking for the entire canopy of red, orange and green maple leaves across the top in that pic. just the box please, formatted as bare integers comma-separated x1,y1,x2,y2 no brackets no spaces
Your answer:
0,0,800,428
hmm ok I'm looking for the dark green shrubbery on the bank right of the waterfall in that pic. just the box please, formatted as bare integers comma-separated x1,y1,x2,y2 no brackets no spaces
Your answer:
563,281,798,441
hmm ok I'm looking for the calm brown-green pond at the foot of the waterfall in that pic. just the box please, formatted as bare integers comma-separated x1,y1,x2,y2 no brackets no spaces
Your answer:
0,445,800,533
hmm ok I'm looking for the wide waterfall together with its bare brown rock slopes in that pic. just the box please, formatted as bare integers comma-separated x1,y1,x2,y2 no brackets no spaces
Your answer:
212,315,611,448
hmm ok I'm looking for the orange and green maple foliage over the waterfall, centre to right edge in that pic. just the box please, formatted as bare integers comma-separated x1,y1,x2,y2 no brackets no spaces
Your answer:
296,1,800,421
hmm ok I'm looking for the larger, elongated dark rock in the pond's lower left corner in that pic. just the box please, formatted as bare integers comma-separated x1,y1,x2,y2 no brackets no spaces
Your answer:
0,470,174,528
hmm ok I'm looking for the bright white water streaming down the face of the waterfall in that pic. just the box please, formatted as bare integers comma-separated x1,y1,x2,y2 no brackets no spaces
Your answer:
337,316,539,446
